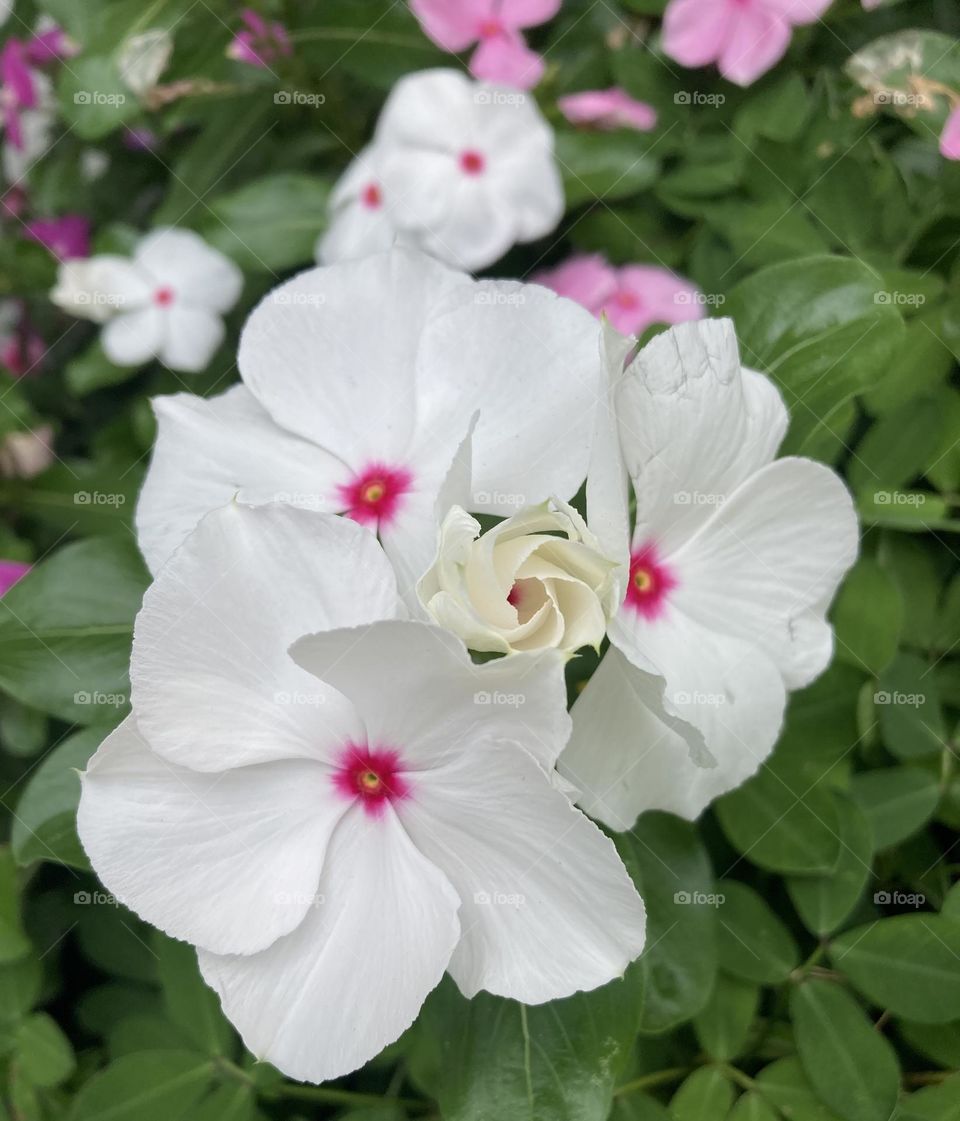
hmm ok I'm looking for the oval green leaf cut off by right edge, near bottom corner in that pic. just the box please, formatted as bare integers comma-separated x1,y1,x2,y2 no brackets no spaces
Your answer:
830,914,960,1023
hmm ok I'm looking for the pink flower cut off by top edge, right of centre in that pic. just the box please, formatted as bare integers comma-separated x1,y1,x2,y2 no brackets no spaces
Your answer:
663,0,832,85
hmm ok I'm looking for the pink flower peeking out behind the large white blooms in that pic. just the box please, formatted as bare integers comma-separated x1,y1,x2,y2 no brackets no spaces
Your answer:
533,253,703,335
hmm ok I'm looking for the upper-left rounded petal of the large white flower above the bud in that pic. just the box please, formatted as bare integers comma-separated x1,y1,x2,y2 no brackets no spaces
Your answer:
238,249,470,471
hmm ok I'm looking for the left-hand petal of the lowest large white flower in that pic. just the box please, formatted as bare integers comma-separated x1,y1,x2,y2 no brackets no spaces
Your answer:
77,716,349,954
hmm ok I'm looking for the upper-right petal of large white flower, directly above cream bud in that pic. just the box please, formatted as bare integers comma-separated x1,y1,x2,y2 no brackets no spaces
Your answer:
417,280,601,517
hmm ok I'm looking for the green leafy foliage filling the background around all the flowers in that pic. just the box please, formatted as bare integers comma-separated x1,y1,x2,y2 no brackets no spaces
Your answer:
0,0,960,1121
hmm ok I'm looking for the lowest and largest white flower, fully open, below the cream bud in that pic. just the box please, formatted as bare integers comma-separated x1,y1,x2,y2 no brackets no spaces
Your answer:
79,504,644,1082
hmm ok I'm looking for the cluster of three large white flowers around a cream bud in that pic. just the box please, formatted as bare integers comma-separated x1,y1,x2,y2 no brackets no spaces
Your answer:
79,249,857,1081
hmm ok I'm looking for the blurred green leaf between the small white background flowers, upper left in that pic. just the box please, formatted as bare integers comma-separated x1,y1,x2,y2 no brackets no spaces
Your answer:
202,173,330,272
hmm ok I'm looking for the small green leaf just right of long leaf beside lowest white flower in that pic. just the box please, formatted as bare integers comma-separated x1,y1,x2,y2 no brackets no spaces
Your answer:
717,880,800,984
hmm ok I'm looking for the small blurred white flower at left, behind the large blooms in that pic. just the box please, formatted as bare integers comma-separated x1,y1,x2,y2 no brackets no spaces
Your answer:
50,228,243,373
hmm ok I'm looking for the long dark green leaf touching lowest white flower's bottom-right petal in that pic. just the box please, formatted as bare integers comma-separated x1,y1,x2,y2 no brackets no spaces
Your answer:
617,813,717,1034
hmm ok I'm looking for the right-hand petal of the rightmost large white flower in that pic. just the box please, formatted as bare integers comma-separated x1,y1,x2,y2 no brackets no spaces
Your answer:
671,458,858,688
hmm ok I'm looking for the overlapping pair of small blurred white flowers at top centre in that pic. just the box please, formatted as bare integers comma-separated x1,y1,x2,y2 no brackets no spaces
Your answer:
319,70,564,270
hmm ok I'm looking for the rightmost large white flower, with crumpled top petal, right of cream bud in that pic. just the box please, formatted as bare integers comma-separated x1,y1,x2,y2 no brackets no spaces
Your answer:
561,319,857,828
